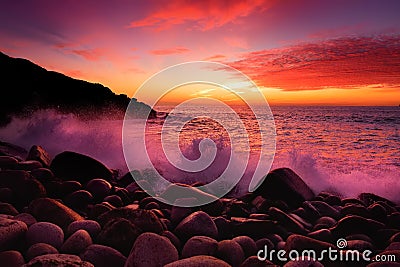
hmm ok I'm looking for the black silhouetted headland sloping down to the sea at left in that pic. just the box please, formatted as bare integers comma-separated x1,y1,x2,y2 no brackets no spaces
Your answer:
0,52,157,125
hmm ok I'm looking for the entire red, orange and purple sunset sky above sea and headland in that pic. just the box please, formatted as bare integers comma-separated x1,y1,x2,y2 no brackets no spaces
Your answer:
0,0,400,105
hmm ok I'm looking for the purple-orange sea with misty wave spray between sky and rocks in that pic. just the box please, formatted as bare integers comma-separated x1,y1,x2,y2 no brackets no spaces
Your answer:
0,107,400,202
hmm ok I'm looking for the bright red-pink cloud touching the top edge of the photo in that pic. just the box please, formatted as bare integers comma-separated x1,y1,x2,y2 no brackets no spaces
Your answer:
129,0,275,31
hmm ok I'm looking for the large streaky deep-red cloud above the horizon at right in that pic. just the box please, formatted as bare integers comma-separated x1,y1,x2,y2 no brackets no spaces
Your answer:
227,35,400,91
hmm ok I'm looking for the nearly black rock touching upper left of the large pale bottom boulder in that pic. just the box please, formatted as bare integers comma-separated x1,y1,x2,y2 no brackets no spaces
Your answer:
97,218,142,256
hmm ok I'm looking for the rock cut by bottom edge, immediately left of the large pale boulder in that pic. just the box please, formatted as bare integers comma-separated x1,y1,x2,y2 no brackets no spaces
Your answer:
80,244,126,267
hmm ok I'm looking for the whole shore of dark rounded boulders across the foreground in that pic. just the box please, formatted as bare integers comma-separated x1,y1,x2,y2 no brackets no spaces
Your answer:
0,143,400,267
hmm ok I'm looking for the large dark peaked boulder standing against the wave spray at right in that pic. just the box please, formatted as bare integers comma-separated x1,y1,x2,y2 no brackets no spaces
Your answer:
254,168,314,207
